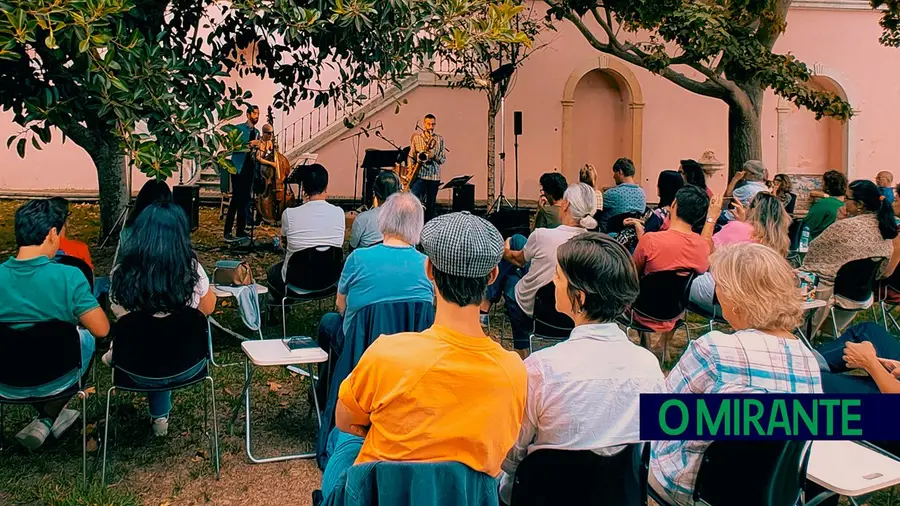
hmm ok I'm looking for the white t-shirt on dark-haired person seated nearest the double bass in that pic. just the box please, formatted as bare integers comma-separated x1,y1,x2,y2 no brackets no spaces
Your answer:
281,200,347,279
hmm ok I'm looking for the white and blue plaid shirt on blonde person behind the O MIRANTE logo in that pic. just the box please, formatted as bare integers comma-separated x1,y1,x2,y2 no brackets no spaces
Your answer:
650,330,822,505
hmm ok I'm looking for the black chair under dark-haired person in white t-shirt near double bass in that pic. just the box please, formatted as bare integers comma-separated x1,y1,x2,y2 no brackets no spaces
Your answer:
270,246,344,337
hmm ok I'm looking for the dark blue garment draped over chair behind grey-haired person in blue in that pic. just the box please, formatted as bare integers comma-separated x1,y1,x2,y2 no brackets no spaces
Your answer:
316,302,434,470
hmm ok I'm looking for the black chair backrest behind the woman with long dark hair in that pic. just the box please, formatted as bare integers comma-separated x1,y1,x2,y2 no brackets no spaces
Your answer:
112,307,209,378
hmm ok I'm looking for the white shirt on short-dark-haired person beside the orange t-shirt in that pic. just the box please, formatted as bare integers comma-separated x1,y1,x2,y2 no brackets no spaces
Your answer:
500,323,665,504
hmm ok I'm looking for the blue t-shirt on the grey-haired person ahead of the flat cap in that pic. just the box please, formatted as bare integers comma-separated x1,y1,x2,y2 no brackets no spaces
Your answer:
338,244,434,332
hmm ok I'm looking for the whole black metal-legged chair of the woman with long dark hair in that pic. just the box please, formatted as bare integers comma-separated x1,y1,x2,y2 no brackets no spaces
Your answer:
101,307,219,484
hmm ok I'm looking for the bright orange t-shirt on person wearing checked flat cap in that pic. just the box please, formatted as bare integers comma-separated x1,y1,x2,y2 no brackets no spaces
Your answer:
338,325,527,476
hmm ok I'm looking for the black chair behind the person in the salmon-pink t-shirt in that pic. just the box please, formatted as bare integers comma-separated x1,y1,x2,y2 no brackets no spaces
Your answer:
617,269,696,356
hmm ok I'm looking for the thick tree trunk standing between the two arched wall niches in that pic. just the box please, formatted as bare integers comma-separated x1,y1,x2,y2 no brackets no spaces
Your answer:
728,85,763,180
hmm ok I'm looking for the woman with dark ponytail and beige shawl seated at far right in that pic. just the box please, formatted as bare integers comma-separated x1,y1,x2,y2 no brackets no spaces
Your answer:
801,179,897,334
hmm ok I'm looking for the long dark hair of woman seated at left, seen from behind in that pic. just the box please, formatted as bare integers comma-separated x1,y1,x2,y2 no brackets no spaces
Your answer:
110,202,200,313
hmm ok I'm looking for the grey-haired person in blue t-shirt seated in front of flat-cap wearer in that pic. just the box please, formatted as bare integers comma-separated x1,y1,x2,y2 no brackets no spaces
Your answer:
319,192,434,360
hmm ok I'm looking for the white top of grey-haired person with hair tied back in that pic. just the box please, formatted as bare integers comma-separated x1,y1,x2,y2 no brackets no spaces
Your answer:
516,225,586,316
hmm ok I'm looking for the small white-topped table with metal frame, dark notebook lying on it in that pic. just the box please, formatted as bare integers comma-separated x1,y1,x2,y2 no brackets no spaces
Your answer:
241,339,328,464
